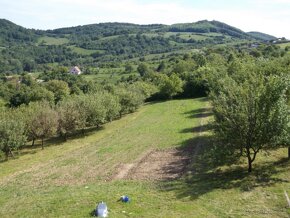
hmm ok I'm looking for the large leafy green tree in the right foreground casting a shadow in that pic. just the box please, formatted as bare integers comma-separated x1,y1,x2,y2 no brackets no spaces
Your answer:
211,62,290,172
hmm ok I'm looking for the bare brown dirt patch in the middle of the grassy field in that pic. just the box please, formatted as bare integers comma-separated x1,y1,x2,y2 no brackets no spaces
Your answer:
113,106,207,181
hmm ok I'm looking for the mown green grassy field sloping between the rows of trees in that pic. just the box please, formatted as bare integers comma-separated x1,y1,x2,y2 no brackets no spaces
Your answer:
0,98,290,217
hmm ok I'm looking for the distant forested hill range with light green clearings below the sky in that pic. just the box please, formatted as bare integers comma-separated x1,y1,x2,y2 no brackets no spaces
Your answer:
0,19,275,73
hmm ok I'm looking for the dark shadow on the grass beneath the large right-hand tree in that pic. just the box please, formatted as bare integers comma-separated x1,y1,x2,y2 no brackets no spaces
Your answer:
160,136,289,200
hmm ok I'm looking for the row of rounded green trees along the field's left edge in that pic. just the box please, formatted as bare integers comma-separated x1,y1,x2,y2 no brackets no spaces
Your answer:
0,82,156,159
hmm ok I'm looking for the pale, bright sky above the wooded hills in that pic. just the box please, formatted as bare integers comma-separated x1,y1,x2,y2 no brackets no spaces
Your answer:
0,0,290,39
